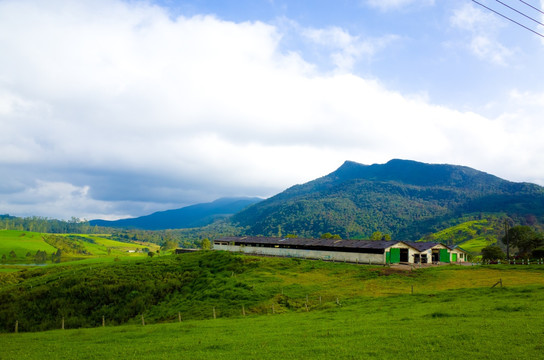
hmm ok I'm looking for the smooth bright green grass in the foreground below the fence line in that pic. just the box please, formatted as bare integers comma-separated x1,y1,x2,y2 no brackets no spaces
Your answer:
0,286,544,359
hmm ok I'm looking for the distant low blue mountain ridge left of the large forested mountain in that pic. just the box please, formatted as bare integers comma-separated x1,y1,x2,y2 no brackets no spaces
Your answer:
89,197,262,230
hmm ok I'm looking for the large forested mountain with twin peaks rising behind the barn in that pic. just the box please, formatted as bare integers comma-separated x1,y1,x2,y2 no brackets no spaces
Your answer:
231,159,544,240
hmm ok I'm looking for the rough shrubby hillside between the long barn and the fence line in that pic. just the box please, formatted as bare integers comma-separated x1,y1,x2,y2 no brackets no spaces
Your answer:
0,251,544,332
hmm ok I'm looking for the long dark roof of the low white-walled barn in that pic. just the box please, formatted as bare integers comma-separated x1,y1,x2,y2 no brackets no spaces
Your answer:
215,236,414,249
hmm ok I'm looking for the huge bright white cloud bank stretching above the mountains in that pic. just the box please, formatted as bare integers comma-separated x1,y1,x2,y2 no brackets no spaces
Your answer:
0,0,544,219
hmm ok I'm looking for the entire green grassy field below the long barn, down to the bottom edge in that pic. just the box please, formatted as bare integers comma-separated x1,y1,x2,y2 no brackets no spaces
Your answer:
0,252,544,359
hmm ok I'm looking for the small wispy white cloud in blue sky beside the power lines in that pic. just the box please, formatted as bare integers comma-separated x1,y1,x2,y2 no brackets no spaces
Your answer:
450,3,515,66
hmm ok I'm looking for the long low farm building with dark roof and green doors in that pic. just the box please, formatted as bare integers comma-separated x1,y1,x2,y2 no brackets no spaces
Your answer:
213,236,460,264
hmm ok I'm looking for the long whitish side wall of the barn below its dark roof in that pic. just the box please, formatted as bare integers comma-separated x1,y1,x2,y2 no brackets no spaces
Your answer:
213,244,386,264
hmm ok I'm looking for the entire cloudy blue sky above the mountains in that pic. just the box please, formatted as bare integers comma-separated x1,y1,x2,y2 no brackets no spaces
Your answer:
0,0,544,220
